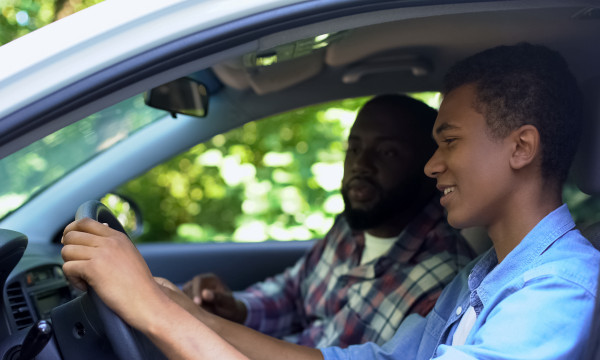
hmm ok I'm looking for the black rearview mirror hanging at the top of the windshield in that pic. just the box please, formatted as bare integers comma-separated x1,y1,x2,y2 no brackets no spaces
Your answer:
144,77,208,117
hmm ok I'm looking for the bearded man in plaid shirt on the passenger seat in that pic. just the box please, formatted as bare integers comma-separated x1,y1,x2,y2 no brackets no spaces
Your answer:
184,95,472,347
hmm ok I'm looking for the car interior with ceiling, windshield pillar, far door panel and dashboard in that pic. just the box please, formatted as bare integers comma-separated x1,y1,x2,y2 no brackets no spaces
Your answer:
0,0,600,359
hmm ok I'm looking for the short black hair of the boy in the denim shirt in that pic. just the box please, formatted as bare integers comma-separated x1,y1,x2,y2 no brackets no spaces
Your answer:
443,43,582,185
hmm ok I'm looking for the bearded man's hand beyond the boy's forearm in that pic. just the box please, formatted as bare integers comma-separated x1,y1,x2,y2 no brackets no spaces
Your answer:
183,274,246,324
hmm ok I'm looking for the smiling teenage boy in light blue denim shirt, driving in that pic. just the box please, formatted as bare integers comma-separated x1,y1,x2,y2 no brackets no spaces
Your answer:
63,44,600,360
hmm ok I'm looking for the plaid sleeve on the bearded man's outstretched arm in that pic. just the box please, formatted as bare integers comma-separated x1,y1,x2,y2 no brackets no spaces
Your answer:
235,239,326,337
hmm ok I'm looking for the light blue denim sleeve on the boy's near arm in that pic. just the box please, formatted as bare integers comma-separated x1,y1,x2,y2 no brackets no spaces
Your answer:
434,275,595,360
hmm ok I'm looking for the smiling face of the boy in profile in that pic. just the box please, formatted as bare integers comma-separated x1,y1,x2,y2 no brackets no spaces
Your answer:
425,84,512,229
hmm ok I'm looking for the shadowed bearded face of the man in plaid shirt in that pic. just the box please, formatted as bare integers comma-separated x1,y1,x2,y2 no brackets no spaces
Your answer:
342,105,426,230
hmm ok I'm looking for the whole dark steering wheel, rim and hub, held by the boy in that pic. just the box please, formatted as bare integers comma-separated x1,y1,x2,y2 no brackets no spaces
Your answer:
51,200,166,360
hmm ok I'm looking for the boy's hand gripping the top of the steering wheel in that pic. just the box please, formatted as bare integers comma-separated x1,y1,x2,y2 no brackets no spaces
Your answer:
61,218,168,329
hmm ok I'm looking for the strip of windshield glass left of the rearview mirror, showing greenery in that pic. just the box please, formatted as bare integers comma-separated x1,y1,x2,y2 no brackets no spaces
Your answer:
0,95,165,219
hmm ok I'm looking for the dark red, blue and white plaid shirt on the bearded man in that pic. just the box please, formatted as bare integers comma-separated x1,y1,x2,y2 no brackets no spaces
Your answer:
236,197,474,347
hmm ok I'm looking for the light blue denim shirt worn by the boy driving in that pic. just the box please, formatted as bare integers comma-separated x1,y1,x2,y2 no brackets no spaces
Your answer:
321,205,600,360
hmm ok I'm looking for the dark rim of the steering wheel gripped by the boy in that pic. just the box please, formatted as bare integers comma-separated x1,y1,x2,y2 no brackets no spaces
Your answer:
75,200,147,360
